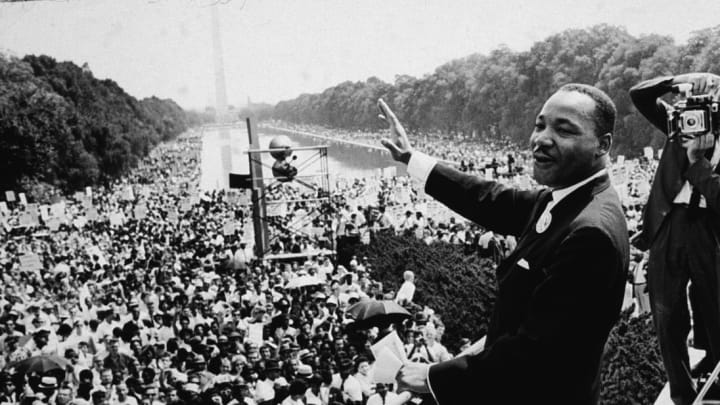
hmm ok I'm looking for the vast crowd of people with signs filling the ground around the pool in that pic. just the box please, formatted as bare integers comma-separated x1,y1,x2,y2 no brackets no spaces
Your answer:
0,123,655,405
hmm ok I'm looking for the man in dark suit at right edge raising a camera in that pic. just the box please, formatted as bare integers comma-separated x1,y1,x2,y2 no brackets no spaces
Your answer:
630,73,720,404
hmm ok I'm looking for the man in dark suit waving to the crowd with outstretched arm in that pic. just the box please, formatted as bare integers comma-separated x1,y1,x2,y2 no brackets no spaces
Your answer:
379,84,629,405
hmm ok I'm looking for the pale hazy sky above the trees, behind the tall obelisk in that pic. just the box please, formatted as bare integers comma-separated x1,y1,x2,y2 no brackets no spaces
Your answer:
0,0,720,108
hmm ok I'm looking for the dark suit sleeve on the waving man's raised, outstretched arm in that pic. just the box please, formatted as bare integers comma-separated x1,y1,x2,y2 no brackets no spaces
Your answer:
425,163,539,236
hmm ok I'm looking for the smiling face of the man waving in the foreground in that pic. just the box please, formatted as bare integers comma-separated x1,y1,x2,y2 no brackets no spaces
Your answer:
530,91,609,188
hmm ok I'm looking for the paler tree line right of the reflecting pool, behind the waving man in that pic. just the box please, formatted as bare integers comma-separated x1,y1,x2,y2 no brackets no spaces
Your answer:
272,24,720,156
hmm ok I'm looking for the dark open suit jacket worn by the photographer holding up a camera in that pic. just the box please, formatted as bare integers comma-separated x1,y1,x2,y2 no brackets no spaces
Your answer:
630,73,720,250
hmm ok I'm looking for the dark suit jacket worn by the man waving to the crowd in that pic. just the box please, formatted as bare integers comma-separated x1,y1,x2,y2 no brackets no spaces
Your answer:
426,164,629,405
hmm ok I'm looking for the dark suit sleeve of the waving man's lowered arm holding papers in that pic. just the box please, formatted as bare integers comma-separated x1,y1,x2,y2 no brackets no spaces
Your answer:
428,228,625,405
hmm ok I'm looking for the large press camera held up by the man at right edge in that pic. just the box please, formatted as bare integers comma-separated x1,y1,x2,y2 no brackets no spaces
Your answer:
667,85,720,139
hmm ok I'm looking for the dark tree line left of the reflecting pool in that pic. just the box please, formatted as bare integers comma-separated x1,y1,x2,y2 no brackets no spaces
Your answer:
0,54,189,192
